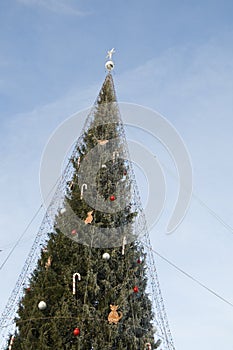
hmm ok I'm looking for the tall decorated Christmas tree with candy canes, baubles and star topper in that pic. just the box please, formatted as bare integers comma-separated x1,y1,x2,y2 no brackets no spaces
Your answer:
0,51,174,350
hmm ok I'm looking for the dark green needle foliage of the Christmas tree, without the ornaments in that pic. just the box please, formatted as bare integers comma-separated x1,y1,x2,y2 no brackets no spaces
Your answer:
8,76,158,350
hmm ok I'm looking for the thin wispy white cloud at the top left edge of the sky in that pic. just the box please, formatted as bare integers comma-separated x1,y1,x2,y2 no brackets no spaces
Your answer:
18,0,87,16
